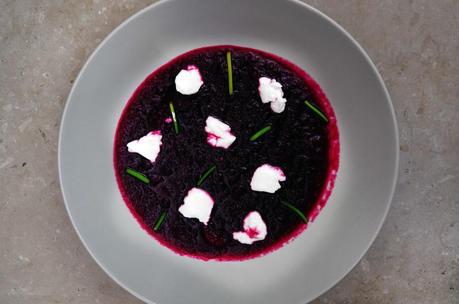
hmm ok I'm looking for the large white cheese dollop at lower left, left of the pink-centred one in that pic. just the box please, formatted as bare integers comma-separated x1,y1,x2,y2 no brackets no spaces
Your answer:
179,188,214,225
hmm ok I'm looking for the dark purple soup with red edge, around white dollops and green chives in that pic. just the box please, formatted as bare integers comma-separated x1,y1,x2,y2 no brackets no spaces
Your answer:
114,46,339,260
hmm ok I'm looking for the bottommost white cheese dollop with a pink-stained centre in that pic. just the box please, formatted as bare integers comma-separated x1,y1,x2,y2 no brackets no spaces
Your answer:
233,211,268,245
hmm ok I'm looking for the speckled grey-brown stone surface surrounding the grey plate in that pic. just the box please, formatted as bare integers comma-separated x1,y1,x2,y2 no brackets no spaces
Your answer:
0,0,459,304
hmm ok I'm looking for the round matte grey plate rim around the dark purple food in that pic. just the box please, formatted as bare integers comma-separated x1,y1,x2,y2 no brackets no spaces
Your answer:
59,0,398,304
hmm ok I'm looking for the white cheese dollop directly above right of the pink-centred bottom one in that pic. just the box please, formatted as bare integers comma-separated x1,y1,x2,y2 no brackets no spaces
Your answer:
250,164,286,193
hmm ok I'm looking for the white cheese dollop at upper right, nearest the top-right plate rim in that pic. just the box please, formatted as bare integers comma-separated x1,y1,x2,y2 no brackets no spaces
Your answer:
258,77,287,113
